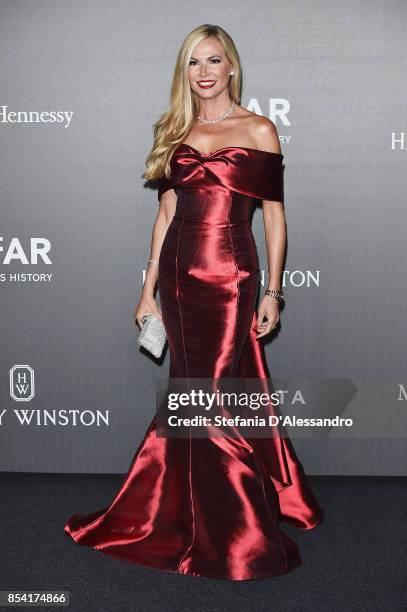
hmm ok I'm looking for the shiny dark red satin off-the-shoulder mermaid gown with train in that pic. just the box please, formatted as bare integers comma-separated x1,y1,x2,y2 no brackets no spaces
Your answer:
65,143,323,580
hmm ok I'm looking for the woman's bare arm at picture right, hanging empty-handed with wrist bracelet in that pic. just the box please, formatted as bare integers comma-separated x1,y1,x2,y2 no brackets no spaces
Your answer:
256,117,287,338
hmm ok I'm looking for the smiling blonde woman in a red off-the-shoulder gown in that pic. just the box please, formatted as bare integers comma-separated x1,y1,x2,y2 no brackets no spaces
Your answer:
65,25,323,580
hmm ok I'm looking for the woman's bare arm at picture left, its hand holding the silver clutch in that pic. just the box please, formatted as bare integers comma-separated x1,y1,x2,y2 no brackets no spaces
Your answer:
134,189,177,328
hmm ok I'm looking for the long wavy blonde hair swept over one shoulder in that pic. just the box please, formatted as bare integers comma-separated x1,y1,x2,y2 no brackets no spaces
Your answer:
142,23,242,181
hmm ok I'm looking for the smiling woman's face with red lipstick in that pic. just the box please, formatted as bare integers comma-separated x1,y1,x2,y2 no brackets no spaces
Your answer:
188,37,232,99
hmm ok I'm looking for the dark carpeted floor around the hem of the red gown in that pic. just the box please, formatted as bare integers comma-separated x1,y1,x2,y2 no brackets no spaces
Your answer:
0,473,407,612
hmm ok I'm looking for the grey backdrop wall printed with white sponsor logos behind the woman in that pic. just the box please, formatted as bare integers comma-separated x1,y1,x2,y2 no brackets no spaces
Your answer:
0,0,407,475
